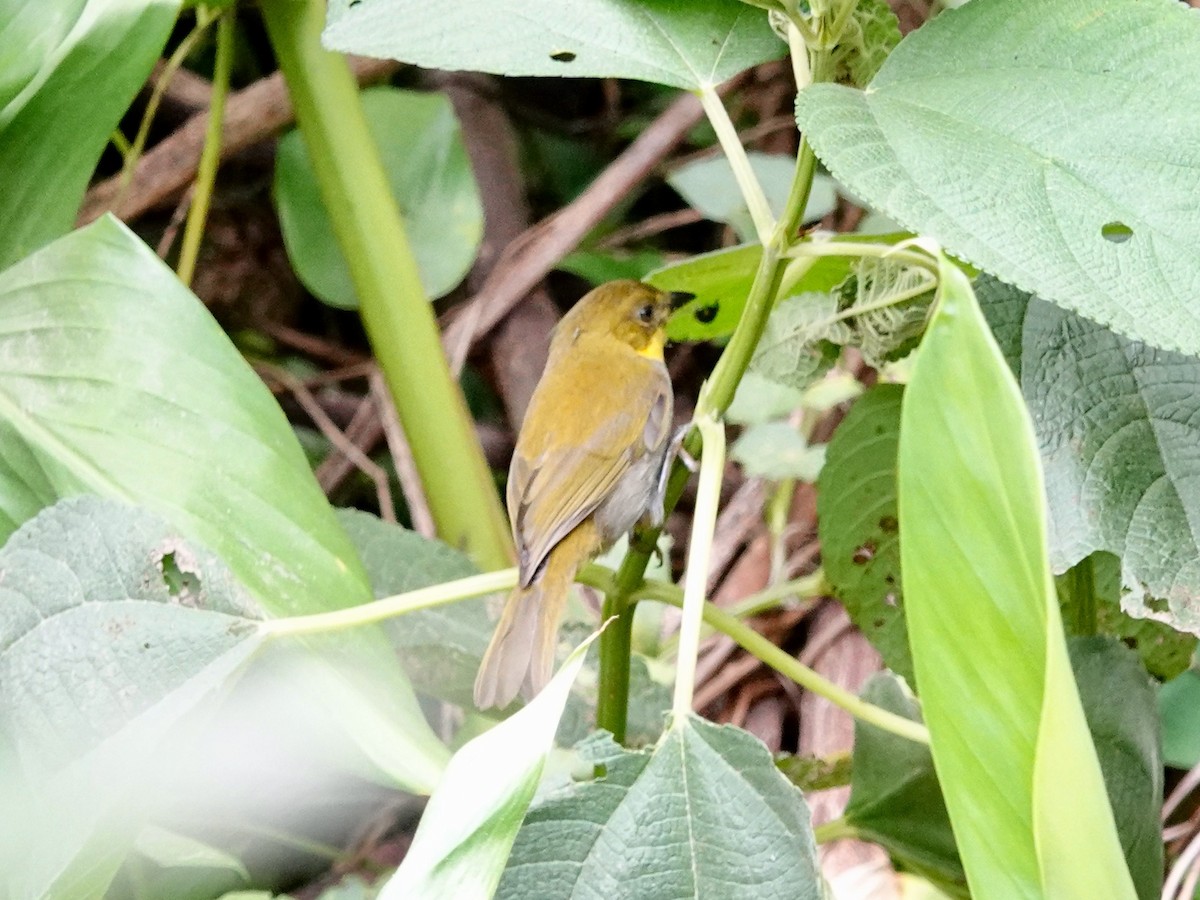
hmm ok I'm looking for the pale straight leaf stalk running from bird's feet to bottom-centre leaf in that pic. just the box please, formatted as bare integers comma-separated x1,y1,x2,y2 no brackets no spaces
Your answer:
672,416,725,727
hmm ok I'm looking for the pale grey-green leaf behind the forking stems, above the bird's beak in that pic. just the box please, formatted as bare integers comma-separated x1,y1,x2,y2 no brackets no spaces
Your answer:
667,151,838,240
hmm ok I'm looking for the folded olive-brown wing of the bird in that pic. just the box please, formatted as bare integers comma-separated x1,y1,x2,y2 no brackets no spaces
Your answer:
508,355,671,586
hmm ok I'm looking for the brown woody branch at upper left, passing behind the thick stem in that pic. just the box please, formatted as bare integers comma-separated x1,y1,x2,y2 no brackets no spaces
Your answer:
77,56,400,224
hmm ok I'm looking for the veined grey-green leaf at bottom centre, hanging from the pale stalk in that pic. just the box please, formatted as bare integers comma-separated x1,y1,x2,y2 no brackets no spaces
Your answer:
497,716,823,900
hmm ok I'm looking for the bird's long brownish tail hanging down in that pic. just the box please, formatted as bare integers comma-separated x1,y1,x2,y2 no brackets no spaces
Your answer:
475,522,595,709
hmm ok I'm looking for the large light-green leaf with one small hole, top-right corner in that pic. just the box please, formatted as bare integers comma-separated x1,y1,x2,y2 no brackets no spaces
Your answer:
797,0,1200,360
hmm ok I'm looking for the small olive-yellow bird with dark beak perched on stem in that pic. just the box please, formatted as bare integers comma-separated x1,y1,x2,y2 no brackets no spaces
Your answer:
475,281,691,709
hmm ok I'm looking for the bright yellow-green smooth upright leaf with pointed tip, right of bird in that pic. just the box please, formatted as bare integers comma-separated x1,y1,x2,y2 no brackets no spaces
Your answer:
898,258,1135,900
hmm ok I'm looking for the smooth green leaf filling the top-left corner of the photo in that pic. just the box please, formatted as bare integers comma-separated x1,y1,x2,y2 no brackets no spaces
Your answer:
0,0,180,269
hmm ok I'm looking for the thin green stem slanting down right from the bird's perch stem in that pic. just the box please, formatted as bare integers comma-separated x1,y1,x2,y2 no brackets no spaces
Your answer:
642,581,929,744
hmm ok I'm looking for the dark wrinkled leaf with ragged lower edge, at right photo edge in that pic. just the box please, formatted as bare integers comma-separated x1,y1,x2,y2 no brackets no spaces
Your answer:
978,277,1200,634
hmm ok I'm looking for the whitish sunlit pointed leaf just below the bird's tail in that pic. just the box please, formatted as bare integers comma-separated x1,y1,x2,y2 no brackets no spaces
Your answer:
379,640,592,900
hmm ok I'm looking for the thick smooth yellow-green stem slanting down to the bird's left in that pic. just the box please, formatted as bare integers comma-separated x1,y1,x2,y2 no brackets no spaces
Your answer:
262,0,512,569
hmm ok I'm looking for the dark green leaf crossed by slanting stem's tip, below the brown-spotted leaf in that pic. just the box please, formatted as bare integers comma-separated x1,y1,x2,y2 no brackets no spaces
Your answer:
845,673,966,894
